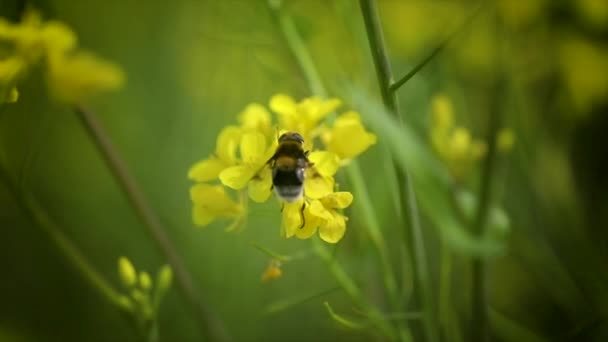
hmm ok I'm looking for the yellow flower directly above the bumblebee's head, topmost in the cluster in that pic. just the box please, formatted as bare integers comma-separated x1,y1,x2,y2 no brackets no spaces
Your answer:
270,94,342,144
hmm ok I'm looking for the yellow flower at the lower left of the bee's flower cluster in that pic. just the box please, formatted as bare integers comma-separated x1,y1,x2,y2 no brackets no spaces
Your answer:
190,183,244,226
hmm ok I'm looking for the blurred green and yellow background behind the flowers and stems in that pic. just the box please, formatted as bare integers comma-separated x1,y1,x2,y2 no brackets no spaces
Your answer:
0,0,608,341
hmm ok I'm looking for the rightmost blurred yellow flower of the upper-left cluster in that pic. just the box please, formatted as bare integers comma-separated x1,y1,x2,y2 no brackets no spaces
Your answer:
47,51,125,104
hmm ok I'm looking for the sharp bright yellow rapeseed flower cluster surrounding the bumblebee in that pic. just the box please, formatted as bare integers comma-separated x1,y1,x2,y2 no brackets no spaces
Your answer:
188,94,376,243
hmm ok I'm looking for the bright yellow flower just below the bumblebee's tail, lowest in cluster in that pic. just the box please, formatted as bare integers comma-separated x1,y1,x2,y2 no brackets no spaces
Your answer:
283,192,353,243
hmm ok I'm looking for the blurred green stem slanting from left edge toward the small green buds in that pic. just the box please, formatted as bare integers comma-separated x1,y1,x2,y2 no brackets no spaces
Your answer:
0,165,129,310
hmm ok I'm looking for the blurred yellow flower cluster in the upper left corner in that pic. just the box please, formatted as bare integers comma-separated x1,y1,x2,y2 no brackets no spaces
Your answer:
0,11,125,104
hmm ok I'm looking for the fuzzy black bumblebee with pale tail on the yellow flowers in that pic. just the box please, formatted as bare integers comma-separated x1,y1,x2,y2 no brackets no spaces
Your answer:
267,132,313,203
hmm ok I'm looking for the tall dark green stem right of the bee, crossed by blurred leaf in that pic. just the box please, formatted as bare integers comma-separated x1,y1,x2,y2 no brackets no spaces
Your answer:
359,0,438,341
